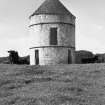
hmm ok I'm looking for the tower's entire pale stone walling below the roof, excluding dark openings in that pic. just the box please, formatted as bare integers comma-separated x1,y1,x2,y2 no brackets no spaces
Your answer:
29,0,75,65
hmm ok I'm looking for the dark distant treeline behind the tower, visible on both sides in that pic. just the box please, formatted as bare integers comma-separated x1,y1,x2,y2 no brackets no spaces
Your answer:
0,50,105,64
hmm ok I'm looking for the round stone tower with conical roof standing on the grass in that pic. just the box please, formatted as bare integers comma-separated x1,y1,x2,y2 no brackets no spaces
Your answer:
29,0,75,65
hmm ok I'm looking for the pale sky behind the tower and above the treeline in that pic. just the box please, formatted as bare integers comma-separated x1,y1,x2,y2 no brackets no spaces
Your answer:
0,0,105,56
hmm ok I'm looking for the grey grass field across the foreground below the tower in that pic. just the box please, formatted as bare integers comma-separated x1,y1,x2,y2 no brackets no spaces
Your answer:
0,64,105,105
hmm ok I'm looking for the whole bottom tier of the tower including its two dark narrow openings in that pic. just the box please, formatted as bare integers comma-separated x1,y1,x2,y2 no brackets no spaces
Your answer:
30,46,75,65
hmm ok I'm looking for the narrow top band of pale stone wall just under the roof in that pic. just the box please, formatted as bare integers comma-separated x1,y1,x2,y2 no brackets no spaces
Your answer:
30,14,75,26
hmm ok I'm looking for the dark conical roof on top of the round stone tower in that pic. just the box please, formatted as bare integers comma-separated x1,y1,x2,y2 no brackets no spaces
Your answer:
31,0,71,16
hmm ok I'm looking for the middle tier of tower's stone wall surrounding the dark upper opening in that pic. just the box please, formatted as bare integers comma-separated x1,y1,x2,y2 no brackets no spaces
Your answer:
30,24,75,47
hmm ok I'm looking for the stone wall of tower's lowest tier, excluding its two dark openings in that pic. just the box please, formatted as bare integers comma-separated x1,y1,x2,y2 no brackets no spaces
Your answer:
30,47,75,65
